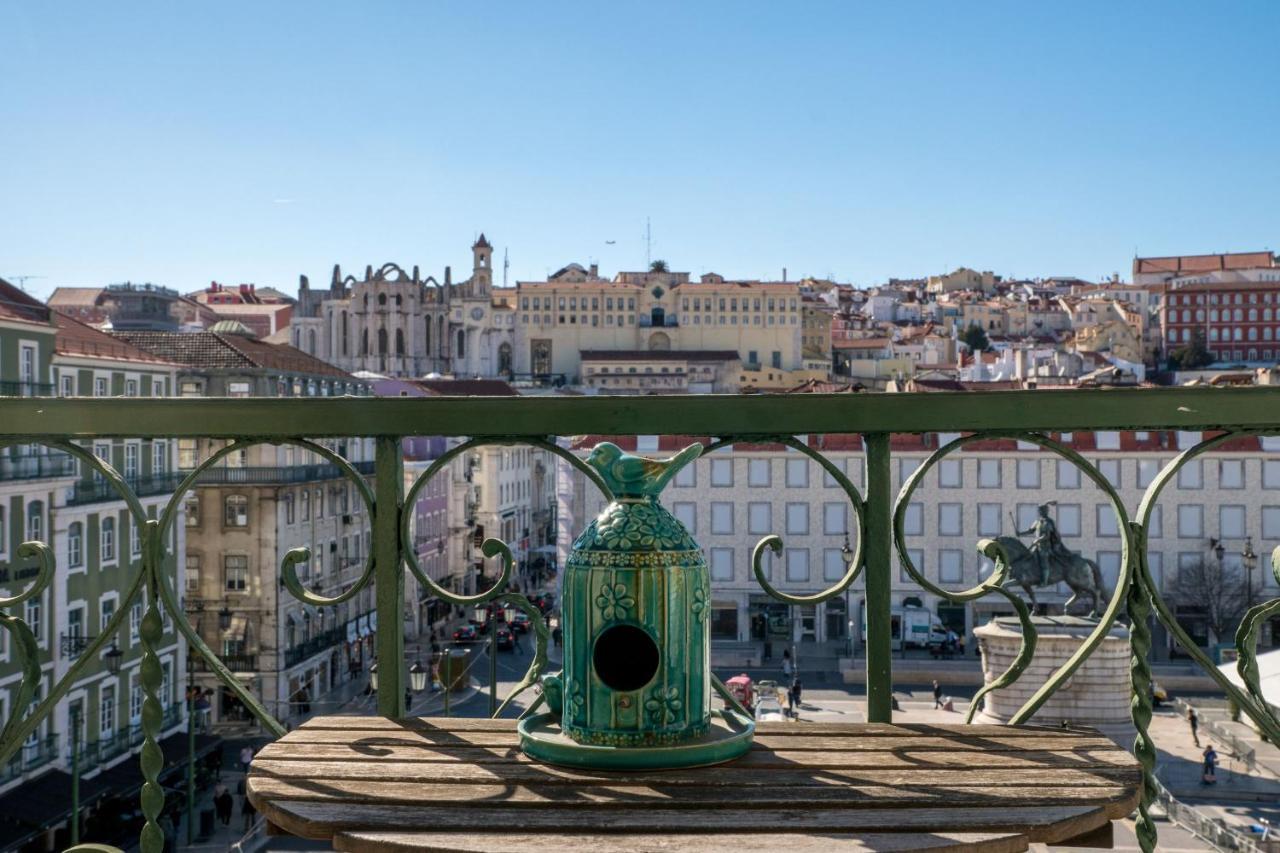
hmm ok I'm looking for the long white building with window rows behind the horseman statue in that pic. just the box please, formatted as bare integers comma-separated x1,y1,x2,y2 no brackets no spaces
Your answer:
567,432,1280,654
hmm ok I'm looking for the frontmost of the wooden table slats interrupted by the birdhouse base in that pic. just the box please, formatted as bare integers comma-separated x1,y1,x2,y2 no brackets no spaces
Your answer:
255,743,1133,770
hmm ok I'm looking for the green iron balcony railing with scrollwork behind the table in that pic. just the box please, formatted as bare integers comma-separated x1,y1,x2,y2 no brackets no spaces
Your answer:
0,388,1280,853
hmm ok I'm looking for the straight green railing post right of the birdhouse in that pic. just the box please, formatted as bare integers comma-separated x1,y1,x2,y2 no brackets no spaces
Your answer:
863,433,893,722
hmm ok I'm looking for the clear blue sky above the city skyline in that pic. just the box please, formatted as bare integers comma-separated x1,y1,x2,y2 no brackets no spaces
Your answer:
0,0,1280,295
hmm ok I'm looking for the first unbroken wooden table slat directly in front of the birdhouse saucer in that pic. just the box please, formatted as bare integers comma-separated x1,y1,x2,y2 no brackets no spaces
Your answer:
253,757,1140,789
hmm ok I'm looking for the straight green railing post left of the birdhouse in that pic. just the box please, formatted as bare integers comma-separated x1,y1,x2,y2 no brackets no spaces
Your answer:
374,435,404,720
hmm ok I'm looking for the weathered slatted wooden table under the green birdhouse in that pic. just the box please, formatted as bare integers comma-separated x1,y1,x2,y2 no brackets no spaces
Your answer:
248,717,1142,853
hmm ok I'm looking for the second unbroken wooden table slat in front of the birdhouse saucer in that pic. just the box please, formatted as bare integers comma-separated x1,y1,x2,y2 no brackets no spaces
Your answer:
248,776,1130,820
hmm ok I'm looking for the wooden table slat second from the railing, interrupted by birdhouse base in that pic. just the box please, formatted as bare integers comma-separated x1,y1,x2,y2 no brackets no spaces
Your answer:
275,729,1114,752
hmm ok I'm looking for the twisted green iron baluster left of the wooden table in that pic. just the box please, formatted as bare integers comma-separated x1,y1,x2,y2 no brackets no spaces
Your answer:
140,520,164,853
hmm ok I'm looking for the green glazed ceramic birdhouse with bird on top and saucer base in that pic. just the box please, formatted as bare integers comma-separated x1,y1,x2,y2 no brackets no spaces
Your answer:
520,442,754,768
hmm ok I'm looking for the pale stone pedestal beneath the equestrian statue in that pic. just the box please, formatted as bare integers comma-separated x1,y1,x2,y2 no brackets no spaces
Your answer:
974,616,1135,745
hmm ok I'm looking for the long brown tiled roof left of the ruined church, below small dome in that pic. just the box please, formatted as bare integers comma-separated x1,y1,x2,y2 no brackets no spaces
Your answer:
111,332,352,379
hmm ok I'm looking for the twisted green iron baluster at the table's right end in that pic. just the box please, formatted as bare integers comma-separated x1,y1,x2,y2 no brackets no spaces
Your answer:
1125,521,1157,853
